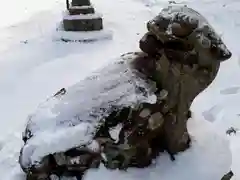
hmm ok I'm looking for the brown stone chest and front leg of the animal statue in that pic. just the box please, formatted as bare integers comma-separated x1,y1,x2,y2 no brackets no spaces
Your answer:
161,56,220,154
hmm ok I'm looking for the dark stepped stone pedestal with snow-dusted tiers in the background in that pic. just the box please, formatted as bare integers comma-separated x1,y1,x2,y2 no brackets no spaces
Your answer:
63,0,103,32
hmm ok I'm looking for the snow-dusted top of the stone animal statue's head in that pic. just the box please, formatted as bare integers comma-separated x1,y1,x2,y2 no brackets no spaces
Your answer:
147,5,232,61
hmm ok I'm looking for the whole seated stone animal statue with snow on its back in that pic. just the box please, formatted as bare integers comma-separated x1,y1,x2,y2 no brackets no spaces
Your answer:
19,6,231,180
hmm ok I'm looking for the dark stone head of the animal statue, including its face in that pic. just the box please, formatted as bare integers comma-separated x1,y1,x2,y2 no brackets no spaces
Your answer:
143,6,232,66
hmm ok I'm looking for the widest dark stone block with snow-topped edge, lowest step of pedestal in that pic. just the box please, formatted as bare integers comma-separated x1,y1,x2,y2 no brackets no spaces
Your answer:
63,14,103,31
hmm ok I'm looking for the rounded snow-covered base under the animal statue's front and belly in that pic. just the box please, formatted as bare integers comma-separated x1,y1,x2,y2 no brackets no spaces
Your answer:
84,118,231,180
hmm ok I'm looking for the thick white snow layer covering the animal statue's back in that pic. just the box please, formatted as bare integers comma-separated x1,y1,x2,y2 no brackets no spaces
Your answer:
21,54,156,167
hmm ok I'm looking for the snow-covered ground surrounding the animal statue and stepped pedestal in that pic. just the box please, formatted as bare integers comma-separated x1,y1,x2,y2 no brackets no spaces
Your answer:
0,0,240,180
